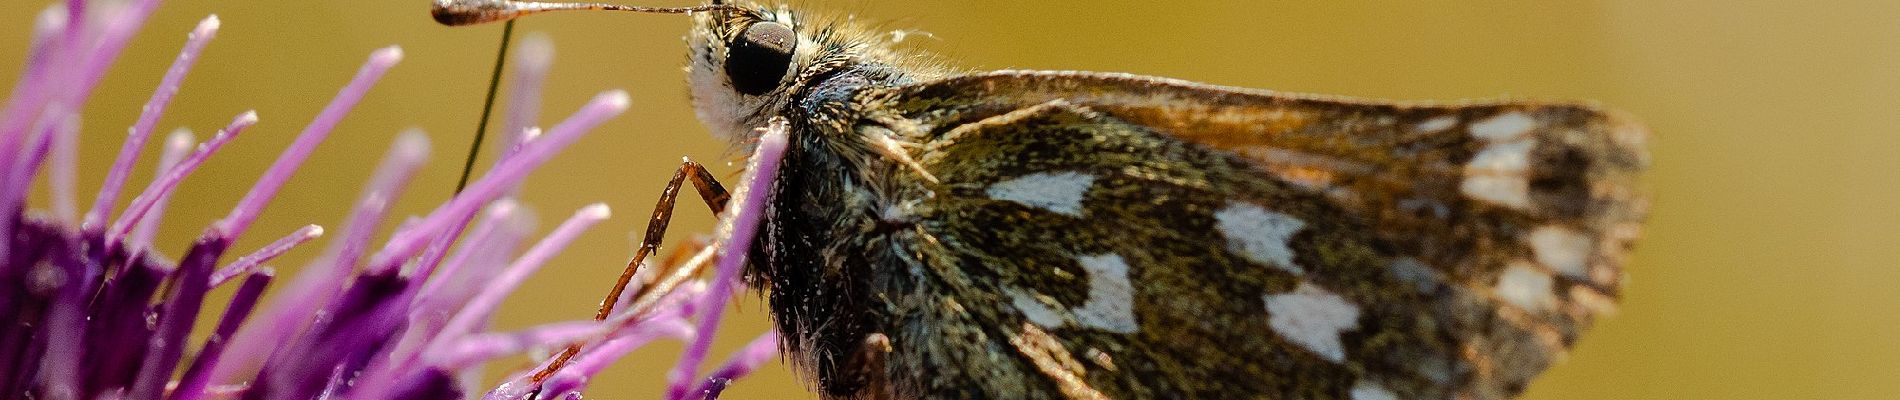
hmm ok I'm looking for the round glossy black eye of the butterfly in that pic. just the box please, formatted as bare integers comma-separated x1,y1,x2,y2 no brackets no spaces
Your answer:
726,21,798,97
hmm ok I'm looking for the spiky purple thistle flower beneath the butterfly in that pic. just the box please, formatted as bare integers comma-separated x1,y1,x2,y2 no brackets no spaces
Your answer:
0,0,783,400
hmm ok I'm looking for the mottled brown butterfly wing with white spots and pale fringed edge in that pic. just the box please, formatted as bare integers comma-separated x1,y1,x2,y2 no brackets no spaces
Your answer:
861,72,1647,398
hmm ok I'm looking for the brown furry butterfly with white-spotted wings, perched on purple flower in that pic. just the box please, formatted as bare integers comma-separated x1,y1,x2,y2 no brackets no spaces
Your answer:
437,2,1649,400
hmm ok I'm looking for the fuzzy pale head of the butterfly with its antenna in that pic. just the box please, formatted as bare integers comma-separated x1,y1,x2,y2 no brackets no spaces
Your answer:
429,0,944,142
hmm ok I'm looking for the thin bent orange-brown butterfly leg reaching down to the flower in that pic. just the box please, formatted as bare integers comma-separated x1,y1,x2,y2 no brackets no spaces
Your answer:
534,159,732,383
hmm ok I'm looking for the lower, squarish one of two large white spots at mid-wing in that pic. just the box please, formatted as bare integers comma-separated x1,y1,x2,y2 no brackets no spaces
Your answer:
1265,282,1359,362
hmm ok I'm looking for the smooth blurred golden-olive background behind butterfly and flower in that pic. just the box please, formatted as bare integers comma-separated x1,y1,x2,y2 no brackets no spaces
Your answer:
0,0,1900,400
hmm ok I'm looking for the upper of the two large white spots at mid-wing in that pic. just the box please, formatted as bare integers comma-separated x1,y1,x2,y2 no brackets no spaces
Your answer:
1214,203,1305,273
